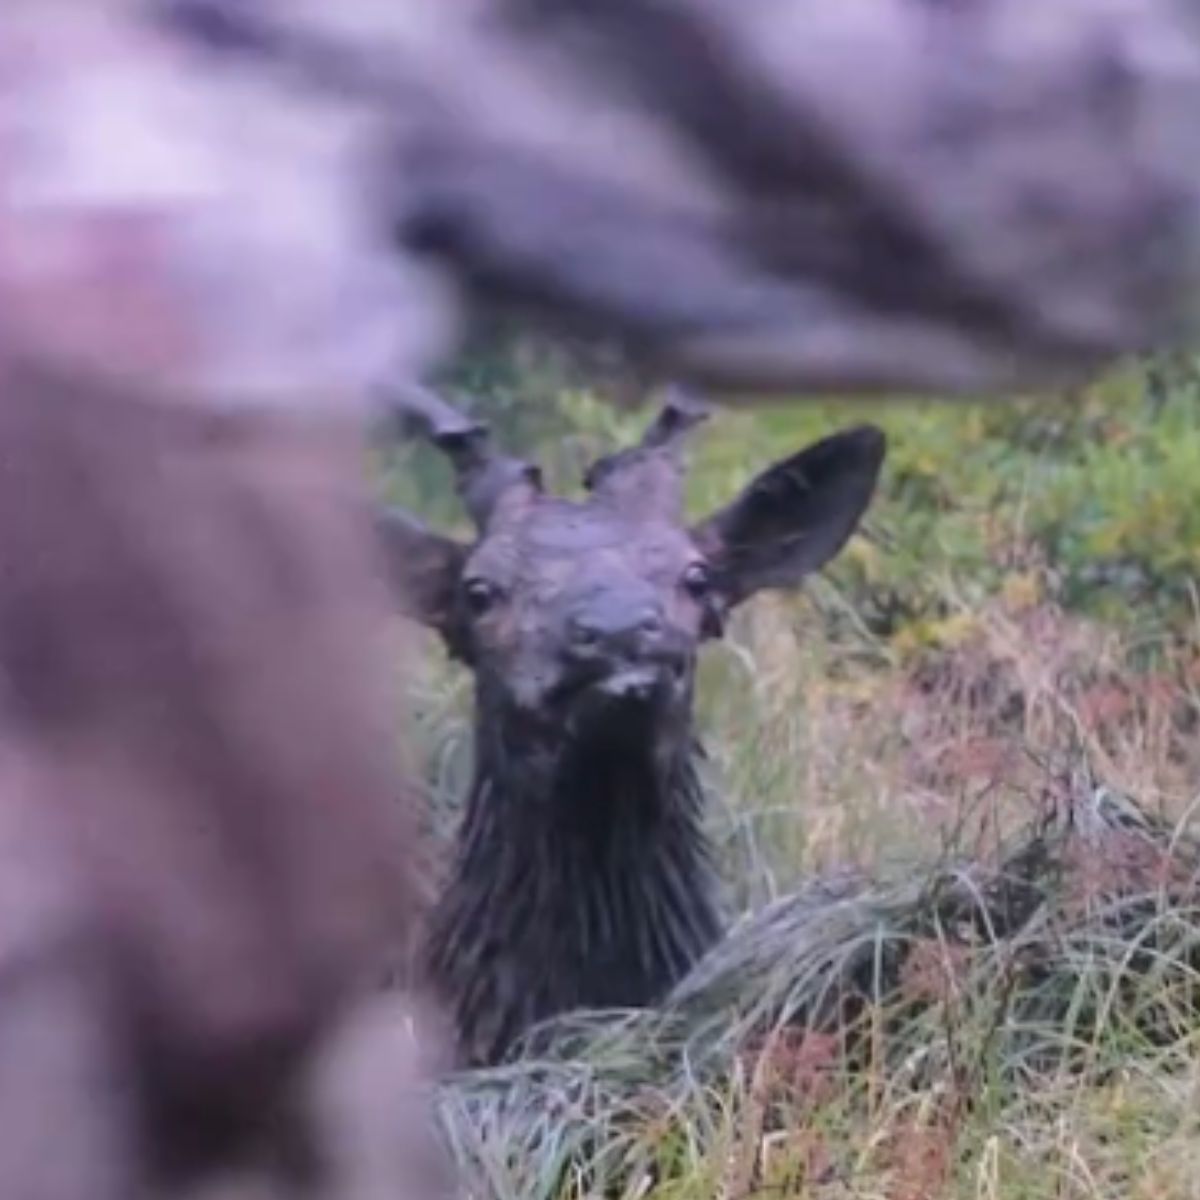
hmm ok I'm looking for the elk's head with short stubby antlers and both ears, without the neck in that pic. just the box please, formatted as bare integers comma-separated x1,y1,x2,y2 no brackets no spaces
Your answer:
380,391,884,758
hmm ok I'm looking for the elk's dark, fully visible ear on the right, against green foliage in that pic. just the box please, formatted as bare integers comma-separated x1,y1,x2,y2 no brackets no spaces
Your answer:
692,425,887,607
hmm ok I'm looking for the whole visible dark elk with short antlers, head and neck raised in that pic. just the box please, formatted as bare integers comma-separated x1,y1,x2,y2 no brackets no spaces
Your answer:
380,391,884,1064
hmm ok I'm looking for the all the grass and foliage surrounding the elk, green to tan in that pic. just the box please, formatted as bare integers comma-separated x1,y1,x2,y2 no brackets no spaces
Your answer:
379,348,1200,1200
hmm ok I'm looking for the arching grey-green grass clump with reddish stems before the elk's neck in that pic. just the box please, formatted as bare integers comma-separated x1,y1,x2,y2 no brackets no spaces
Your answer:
442,772,1200,1198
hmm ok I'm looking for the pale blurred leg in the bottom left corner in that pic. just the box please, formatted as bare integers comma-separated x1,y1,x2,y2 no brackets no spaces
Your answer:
0,749,145,1200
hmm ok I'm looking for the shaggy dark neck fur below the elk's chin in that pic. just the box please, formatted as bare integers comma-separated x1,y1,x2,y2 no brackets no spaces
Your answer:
428,697,721,1063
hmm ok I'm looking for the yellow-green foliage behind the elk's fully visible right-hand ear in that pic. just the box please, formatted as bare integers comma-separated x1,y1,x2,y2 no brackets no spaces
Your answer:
676,364,1200,644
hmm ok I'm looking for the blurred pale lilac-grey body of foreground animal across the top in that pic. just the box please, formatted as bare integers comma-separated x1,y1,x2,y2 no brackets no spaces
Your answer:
9,0,1200,406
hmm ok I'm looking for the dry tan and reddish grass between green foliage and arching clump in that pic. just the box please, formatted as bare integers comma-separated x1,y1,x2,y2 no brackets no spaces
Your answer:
703,552,1200,898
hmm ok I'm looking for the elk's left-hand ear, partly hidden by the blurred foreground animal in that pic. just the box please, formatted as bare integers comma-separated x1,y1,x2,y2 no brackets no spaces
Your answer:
376,508,469,649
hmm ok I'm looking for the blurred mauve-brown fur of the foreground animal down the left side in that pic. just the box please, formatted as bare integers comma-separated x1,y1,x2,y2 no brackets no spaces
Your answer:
0,350,436,1200
